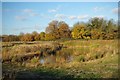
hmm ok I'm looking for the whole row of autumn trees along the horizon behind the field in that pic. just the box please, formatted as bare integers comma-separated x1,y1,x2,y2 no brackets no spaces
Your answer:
1,17,118,42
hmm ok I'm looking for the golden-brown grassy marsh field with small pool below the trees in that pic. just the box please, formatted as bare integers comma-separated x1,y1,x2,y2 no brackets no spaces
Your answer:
2,40,118,80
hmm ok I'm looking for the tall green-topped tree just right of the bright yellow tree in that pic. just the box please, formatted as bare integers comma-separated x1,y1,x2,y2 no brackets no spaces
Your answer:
88,17,109,39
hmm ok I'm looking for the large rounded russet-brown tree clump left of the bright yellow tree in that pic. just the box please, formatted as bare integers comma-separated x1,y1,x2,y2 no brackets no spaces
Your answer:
45,21,71,40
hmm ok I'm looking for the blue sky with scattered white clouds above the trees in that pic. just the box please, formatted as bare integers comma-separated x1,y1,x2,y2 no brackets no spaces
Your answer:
2,2,118,34
